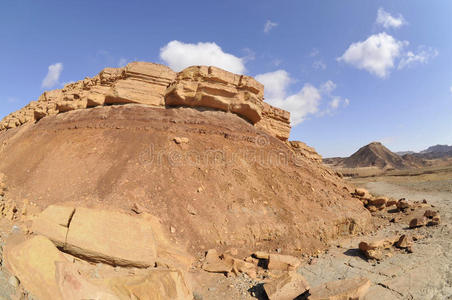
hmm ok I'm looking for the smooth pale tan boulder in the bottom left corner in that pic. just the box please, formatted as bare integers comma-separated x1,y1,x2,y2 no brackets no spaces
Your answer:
5,236,66,299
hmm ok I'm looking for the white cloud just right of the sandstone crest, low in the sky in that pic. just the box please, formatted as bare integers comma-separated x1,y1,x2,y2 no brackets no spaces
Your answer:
256,70,349,126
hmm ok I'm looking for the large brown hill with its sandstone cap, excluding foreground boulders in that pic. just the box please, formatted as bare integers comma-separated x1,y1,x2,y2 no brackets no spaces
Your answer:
0,63,369,254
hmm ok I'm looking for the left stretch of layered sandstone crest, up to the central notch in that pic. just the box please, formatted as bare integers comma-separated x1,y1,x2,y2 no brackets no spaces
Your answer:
0,62,176,130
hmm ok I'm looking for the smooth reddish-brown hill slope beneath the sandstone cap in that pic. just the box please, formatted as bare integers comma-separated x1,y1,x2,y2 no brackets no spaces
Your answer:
0,104,370,255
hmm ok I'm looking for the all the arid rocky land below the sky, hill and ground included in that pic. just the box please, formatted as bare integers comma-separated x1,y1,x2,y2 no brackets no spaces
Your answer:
0,62,452,300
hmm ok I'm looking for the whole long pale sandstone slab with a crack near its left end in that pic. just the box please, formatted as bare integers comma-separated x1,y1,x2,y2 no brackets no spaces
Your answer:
32,206,157,267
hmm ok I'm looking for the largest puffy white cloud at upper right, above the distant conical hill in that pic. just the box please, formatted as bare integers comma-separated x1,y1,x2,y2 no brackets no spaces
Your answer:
337,32,409,78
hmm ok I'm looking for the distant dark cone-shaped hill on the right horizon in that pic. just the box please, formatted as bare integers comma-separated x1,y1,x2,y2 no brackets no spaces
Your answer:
323,142,425,169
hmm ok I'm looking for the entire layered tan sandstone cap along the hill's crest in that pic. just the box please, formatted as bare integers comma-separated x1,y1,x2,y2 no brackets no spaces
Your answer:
0,62,290,140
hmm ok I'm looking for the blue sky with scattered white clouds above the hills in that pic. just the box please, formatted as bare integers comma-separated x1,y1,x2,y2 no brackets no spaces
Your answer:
0,0,452,157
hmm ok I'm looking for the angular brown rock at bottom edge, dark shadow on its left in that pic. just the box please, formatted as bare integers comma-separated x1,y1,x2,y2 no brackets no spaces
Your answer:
264,272,309,300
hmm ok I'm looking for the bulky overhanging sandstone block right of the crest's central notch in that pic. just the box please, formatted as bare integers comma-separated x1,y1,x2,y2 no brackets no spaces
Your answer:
165,66,264,124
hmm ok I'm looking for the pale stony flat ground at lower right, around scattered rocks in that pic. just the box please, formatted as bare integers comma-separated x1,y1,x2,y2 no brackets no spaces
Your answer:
299,180,452,300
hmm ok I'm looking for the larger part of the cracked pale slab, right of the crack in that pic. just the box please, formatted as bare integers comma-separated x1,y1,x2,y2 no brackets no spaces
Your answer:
64,208,157,267
